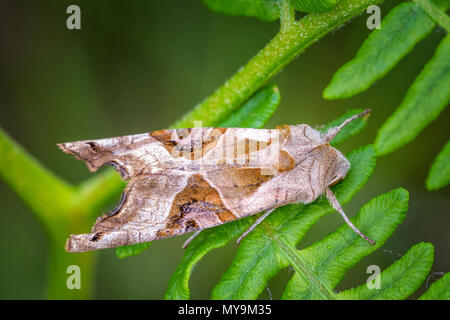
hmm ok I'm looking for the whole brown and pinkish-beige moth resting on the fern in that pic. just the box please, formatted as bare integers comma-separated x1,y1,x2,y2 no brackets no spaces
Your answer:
58,110,374,252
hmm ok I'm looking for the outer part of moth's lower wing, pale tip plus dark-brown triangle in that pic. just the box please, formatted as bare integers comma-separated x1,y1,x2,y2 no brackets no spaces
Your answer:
66,170,248,252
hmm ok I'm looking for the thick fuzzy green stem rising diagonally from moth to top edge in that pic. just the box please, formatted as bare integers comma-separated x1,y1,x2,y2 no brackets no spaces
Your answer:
174,0,382,128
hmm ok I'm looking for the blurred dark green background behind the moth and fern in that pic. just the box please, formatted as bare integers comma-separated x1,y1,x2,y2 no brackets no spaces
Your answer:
0,0,450,299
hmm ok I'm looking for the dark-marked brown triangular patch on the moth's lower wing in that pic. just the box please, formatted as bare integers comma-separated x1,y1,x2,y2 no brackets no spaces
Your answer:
158,174,237,237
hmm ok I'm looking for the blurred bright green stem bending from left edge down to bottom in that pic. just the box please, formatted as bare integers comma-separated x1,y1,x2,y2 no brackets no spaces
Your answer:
0,129,98,299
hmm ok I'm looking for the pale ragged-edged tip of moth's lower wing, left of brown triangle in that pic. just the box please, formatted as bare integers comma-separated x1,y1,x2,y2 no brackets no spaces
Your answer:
66,174,187,252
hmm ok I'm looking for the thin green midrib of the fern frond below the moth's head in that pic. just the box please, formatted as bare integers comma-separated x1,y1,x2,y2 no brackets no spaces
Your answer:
273,236,337,300
